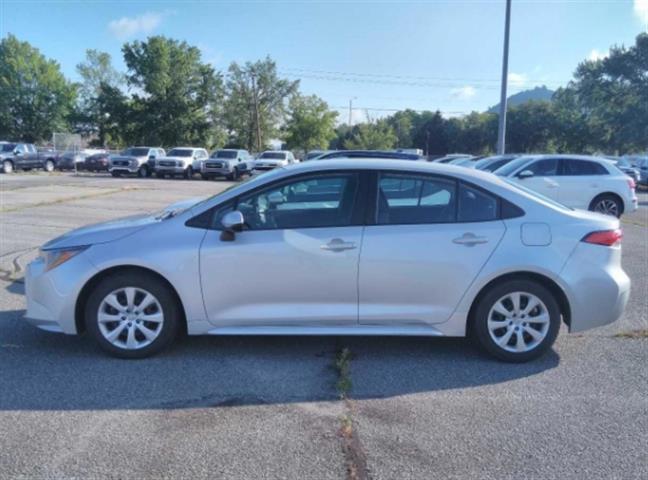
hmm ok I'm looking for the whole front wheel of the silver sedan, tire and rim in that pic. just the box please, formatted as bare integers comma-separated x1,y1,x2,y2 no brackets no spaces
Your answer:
85,272,181,358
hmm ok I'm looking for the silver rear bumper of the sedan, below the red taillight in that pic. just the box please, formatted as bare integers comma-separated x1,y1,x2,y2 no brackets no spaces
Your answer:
560,243,630,332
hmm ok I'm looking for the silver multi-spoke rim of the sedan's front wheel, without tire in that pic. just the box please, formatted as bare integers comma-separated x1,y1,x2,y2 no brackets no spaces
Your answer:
97,287,164,350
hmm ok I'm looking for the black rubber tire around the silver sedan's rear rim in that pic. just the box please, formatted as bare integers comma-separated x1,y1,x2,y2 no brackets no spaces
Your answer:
471,279,560,363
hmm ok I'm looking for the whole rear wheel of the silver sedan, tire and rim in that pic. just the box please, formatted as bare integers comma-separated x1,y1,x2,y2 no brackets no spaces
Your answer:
472,280,560,362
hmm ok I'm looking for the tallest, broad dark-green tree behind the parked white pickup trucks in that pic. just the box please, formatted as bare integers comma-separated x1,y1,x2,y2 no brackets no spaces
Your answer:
122,36,224,147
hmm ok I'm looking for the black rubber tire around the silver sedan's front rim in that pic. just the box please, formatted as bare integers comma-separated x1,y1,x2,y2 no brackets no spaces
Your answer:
84,271,182,359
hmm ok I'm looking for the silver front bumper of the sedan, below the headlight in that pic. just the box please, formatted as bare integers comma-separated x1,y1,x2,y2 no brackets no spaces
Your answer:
24,251,97,334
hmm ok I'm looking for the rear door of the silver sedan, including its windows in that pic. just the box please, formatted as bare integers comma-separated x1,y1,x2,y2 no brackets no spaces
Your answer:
358,172,505,326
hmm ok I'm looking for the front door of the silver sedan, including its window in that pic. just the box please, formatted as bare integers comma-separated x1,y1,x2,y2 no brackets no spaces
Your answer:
200,171,364,326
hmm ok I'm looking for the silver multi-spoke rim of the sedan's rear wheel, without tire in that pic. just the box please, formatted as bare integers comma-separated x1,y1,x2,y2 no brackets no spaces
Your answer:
488,292,550,353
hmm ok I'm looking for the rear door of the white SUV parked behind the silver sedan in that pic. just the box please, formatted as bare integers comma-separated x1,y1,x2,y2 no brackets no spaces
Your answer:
560,158,609,209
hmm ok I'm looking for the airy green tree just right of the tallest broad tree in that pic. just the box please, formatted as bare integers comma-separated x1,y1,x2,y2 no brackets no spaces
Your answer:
225,57,299,151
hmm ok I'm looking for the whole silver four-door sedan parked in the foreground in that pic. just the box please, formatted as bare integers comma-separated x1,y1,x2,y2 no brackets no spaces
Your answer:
26,159,630,361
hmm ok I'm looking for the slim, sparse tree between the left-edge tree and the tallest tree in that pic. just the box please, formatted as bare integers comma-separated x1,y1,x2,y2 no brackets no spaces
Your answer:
76,49,124,146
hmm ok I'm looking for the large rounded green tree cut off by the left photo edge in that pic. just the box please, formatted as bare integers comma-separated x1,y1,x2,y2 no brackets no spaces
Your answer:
0,34,76,142
